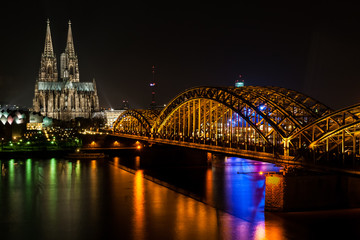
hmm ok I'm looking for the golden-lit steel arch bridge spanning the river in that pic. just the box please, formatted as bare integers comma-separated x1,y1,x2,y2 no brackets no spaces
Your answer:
113,86,360,161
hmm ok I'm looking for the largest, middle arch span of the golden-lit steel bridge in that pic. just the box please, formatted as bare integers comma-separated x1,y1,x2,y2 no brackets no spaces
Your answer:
151,87,330,155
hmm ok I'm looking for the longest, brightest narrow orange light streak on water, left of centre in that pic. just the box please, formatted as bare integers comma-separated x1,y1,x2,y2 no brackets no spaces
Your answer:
134,170,145,239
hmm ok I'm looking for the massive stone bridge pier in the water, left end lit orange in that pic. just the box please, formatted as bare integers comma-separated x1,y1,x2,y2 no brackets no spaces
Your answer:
265,171,360,212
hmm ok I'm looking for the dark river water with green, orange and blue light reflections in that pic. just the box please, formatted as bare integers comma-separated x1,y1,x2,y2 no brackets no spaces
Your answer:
0,156,360,240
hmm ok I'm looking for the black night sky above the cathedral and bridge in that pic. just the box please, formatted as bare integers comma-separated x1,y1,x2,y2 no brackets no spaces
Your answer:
0,1,360,109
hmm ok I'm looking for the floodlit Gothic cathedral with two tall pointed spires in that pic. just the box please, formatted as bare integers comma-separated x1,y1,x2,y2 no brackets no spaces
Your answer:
33,20,99,121
